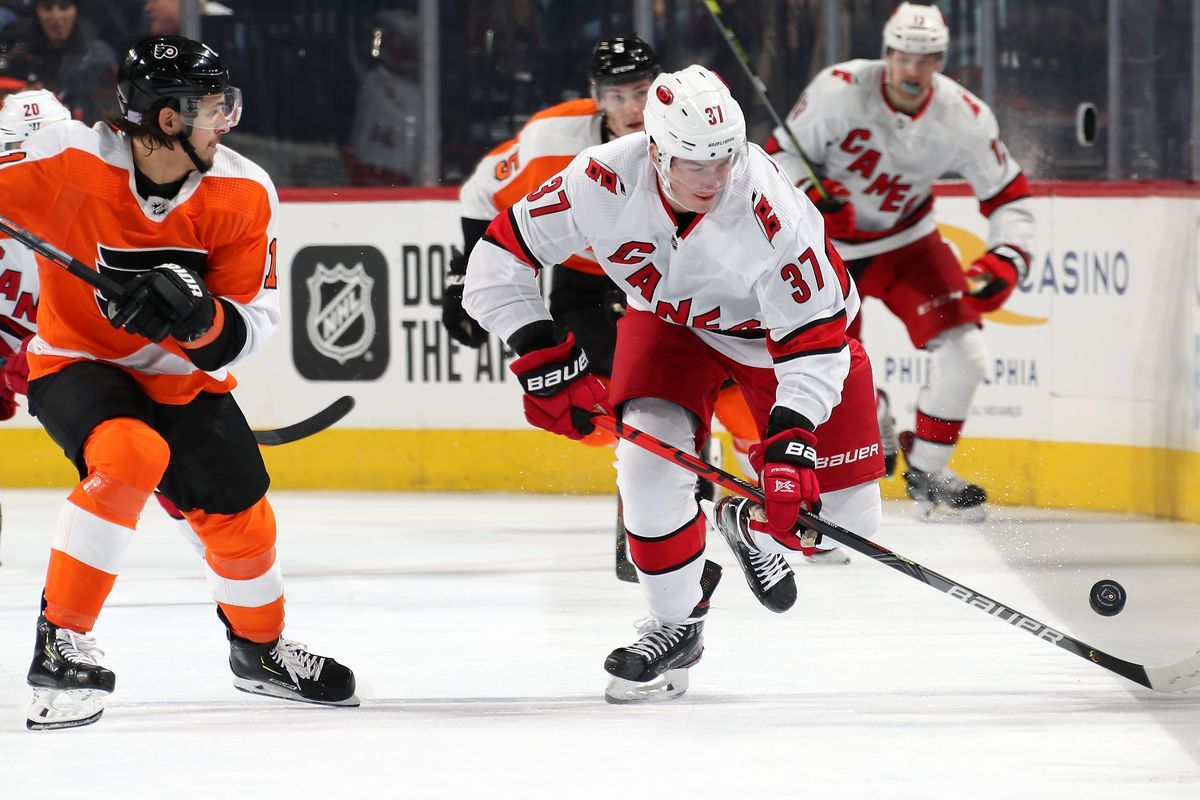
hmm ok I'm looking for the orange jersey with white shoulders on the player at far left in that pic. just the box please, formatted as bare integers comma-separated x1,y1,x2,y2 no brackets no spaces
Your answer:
0,122,280,404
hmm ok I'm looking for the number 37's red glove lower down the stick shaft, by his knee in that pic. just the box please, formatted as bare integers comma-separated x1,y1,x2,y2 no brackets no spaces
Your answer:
750,428,821,549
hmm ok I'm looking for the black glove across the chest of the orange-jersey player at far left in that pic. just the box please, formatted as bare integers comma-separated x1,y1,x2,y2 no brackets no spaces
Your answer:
107,264,216,342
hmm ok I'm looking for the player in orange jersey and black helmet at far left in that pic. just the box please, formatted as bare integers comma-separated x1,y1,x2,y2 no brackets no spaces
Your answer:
0,36,358,729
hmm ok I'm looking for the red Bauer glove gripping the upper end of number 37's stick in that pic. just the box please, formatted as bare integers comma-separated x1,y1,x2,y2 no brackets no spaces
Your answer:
509,332,612,439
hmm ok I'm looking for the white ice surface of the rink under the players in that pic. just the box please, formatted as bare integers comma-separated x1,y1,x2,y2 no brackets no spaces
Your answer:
0,491,1200,800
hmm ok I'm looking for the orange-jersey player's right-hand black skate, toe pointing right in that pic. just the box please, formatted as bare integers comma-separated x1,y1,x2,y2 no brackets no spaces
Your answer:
217,609,359,705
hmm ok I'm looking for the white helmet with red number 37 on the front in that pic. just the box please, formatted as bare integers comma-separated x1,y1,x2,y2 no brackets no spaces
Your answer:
644,64,746,206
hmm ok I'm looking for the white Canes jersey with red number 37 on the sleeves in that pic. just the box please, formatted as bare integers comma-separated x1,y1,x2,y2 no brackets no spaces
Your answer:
464,133,859,425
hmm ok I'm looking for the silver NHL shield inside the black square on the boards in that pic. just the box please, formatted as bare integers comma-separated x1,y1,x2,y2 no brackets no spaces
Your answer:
307,261,376,363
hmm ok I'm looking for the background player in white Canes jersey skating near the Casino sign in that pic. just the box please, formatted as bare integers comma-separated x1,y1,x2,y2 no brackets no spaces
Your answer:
767,2,1033,519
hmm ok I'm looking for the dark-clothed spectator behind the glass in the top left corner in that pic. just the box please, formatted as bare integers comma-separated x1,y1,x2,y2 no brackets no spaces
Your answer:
4,0,116,125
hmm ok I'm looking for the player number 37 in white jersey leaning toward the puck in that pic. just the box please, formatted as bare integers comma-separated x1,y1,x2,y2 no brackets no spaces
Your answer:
466,66,883,703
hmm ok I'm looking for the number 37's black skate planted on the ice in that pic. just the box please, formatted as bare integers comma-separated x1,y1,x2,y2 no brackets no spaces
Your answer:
604,561,721,703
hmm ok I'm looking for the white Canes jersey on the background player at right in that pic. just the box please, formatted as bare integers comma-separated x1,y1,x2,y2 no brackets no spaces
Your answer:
767,60,1033,259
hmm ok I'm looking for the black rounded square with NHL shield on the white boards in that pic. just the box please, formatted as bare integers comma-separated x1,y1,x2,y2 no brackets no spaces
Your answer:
292,246,390,380
